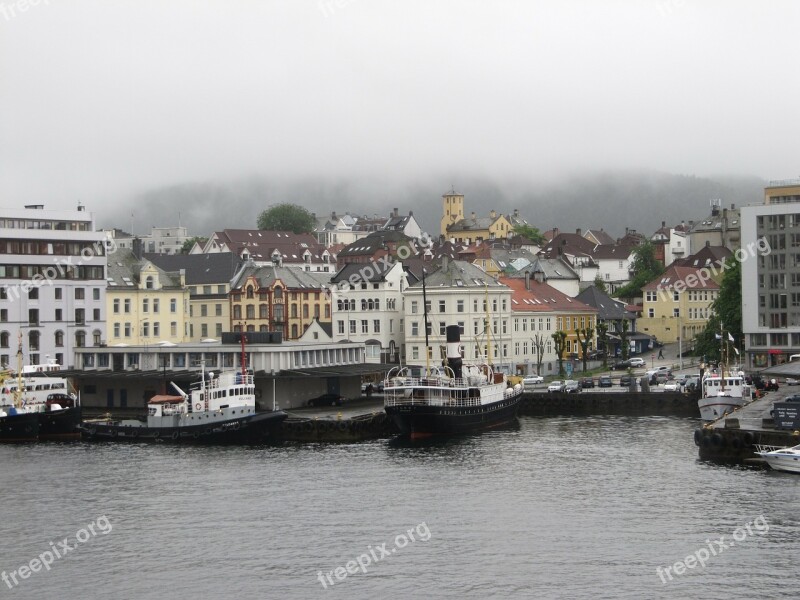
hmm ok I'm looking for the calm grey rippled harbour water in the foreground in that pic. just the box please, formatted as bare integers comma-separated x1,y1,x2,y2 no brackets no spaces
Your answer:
0,417,800,600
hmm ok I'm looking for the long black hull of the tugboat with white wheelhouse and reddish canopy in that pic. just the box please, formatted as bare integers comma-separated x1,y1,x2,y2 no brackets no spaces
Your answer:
80,411,288,445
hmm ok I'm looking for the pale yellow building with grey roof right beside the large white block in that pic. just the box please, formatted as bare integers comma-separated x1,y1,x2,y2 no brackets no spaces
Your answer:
106,249,189,346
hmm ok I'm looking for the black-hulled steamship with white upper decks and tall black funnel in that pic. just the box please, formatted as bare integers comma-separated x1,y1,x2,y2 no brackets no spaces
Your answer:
383,325,523,439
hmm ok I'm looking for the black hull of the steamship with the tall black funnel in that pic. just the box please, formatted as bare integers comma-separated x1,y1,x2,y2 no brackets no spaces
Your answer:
385,393,522,439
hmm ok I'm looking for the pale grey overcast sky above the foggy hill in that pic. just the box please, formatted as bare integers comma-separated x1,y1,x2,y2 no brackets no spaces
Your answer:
0,0,800,223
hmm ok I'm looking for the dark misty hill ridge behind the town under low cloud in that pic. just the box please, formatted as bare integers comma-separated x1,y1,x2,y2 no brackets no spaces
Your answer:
103,170,766,237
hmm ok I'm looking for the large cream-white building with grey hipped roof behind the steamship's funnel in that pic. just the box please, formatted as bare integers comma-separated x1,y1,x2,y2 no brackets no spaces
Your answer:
402,257,512,366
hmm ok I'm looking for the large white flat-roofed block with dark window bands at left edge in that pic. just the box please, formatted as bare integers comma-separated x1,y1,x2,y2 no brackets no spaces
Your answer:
0,205,108,368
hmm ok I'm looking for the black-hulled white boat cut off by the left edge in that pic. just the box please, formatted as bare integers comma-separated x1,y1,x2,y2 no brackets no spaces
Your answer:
0,335,81,442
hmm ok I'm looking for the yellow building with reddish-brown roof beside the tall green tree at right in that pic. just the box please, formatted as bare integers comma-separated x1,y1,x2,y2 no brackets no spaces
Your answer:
637,265,722,347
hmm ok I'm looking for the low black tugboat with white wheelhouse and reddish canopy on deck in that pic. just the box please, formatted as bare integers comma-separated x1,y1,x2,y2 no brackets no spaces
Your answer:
80,370,288,444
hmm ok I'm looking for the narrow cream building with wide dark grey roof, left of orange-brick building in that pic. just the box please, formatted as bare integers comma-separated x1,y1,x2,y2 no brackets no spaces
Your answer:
146,252,242,342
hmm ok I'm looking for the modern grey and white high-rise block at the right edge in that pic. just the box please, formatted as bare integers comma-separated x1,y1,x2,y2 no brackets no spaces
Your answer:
741,179,800,368
